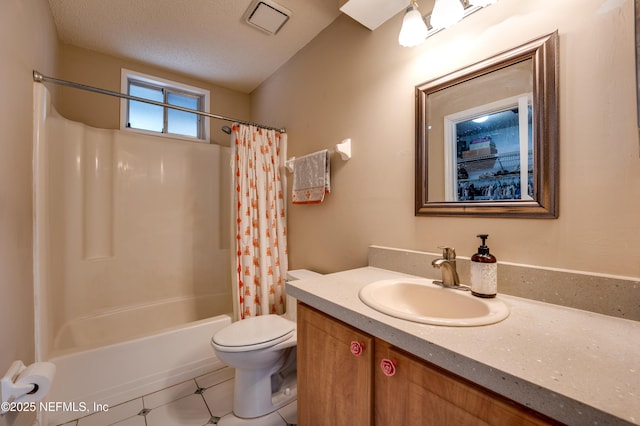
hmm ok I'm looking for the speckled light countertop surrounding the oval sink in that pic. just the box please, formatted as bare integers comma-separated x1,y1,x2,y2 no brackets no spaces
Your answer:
287,267,640,425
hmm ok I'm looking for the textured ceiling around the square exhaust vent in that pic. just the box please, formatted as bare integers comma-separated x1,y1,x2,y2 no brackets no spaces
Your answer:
49,0,340,93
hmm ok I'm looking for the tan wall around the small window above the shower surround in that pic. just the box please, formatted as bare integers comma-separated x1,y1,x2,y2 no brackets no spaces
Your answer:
54,45,250,146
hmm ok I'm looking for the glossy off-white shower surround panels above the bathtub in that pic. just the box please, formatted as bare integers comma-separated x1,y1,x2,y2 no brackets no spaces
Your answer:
33,83,233,361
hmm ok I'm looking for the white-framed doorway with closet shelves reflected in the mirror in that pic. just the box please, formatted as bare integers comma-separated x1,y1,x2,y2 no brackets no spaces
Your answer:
444,94,534,201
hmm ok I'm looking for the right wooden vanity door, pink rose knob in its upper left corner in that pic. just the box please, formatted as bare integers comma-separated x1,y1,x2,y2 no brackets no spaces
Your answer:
374,339,550,426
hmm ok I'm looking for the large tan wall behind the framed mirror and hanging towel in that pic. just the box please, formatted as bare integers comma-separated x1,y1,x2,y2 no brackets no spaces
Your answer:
252,0,640,277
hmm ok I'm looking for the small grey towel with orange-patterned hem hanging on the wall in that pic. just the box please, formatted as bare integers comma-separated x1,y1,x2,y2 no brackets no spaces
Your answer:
291,149,331,204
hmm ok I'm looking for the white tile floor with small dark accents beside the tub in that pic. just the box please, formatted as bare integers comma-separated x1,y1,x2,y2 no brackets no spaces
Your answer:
56,367,297,426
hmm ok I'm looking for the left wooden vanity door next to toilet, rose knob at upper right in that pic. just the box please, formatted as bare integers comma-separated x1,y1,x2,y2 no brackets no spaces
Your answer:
297,303,373,426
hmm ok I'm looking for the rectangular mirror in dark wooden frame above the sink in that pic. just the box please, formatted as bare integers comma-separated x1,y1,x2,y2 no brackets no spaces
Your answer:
415,32,558,218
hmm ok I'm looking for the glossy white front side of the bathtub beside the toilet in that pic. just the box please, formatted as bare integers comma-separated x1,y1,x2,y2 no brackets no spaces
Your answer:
41,314,231,425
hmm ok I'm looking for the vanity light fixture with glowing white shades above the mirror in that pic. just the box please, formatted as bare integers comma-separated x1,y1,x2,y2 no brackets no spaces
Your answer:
398,0,498,47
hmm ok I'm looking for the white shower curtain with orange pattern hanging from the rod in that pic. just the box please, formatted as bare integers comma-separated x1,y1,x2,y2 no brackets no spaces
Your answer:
231,123,288,319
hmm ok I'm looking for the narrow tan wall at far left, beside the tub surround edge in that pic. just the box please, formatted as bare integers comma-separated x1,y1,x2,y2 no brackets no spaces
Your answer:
0,0,58,370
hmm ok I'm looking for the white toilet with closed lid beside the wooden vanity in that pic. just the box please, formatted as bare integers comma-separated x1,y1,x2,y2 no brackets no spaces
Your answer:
211,269,320,426
